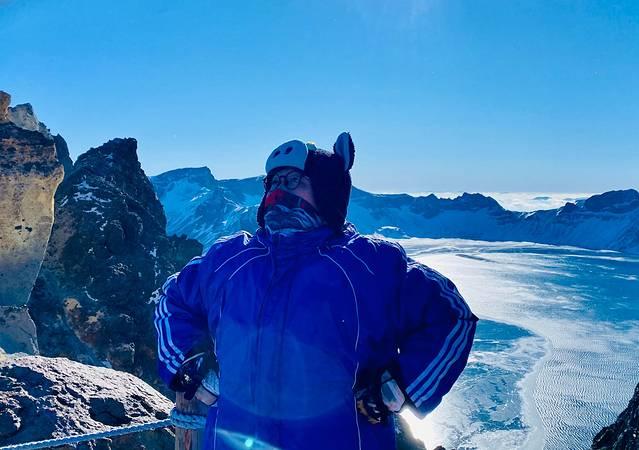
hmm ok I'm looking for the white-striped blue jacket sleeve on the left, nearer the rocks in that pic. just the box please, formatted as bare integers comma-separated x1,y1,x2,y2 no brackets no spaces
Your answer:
154,251,208,385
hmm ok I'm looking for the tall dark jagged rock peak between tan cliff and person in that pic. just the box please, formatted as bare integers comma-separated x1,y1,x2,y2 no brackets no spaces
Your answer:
29,139,202,387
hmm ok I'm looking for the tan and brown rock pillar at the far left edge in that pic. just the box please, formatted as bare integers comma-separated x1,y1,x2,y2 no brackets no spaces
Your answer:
0,92,64,353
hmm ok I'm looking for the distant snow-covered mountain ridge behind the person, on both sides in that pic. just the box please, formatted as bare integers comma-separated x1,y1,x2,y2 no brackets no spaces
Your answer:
150,167,639,253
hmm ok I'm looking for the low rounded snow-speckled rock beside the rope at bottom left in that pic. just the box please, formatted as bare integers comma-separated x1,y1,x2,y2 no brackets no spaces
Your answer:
0,356,174,450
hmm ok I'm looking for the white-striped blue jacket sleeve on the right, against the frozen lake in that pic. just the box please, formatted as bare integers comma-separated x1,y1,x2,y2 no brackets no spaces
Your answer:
398,254,478,416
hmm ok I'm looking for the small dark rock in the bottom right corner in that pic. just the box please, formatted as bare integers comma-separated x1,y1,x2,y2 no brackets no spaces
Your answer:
592,384,639,450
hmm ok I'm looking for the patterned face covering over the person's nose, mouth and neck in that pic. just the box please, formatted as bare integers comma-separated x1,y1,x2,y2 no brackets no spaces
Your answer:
264,189,324,234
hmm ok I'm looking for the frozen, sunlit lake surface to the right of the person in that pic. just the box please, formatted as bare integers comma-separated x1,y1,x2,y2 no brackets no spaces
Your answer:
398,239,639,450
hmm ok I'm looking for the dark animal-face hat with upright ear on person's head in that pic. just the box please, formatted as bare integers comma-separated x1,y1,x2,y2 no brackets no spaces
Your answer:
257,132,355,231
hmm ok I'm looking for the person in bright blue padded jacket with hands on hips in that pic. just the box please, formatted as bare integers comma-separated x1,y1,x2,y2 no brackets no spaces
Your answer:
155,133,477,450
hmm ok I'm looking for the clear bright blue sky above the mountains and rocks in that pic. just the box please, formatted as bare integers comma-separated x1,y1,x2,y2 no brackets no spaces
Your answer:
0,0,639,192
